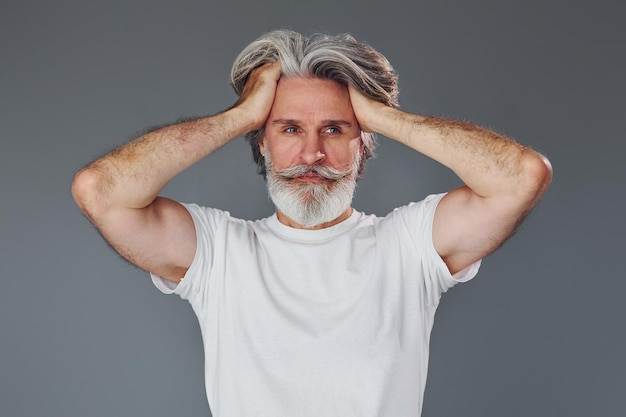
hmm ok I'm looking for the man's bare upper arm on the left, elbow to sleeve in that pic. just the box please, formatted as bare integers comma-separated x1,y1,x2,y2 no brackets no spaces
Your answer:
96,197,196,282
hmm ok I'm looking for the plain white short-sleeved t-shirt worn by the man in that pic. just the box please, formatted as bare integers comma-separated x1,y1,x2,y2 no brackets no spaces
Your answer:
153,195,480,417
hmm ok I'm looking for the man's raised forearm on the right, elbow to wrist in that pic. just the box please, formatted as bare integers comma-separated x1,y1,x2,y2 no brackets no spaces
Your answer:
370,108,549,197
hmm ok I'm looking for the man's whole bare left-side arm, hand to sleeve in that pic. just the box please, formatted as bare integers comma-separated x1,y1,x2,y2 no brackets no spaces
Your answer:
72,63,280,282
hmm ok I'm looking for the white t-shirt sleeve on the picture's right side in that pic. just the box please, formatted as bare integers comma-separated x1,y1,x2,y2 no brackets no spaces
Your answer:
394,194,481,305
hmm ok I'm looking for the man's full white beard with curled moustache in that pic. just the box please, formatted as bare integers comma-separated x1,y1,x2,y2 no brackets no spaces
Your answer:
265,149,361,228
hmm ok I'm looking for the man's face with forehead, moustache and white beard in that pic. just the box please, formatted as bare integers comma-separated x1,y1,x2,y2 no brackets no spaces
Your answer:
260,77,362,227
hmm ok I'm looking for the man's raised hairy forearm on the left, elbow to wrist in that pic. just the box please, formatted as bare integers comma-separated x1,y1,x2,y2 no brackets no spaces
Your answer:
73,108,249,214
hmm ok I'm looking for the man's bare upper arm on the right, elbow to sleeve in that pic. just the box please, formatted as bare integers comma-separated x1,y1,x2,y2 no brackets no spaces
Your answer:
433,186,531,274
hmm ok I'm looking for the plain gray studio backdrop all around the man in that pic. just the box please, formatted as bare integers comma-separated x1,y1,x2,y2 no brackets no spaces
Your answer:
0,0,626,417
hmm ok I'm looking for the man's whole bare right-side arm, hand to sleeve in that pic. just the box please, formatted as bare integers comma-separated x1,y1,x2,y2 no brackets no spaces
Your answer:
350,88,552,274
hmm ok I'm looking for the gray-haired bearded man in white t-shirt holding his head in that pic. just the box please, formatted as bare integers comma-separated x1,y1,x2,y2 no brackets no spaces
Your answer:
73,31,551,417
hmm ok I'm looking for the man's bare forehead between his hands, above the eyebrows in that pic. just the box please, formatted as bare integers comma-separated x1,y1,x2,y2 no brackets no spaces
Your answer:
269,77,354,120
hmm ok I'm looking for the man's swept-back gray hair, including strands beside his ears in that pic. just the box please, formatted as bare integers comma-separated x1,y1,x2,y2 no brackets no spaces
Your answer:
230,30,398,178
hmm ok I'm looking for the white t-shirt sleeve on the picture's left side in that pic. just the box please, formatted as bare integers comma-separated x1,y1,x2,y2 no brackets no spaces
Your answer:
150,204,229,303
